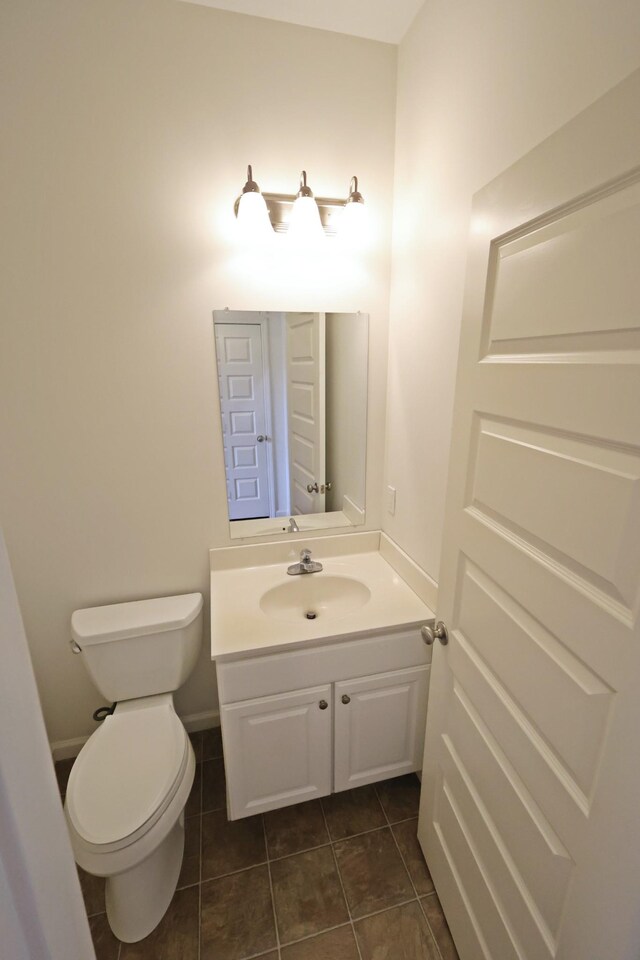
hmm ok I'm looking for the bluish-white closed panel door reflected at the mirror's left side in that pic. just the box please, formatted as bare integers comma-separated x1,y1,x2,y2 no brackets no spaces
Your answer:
215,323,270,520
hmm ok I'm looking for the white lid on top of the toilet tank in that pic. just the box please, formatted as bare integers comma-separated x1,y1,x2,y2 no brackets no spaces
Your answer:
71,593,202,646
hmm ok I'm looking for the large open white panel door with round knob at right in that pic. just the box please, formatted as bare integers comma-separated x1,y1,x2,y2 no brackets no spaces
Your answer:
419,71,640,960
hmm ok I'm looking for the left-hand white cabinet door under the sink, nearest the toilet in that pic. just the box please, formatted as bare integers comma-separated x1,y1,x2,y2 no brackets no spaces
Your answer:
220,684,333,820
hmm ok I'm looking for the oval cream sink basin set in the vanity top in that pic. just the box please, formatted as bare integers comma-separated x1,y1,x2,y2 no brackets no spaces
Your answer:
260,573,371,621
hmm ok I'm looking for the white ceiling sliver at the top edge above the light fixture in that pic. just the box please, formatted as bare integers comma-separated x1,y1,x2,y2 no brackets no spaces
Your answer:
176,0,423,43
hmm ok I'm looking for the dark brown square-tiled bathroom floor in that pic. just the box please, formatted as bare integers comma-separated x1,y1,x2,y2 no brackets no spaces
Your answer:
56,728,458,960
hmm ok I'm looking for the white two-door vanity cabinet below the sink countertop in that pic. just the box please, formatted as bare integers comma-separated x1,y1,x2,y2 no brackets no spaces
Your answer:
217,628,431,820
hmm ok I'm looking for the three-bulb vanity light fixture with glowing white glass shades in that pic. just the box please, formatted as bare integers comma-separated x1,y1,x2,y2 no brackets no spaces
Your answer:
234,166,364,237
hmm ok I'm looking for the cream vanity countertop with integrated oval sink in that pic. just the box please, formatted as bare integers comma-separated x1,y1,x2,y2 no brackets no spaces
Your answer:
211,549,433,661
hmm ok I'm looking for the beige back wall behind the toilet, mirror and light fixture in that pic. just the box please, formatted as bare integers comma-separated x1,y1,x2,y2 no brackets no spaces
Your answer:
0,0,396,741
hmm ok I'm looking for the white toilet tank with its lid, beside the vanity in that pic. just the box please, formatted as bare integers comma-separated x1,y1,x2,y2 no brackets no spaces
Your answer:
71,593,202,701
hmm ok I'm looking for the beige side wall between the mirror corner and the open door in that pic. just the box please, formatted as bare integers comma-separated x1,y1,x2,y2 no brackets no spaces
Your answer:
383,0,640,580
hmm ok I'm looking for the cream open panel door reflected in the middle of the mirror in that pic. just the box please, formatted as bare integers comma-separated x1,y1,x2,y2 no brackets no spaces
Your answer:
286,313,326,514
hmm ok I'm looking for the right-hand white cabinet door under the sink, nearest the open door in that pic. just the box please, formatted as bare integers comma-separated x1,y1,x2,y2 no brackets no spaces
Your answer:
335,665,429,791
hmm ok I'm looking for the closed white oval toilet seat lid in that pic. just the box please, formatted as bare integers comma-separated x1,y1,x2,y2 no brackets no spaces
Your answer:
66,704,188,844
